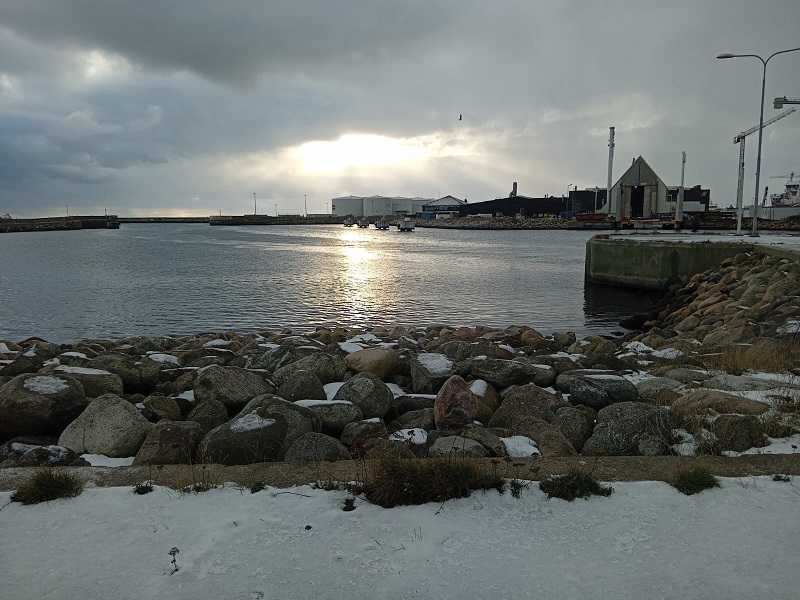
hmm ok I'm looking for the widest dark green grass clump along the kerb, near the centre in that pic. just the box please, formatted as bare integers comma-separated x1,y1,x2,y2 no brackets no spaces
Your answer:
363,458,505,508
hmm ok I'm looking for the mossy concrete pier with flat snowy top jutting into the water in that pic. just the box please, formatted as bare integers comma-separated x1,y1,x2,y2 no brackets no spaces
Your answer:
585,235,800,291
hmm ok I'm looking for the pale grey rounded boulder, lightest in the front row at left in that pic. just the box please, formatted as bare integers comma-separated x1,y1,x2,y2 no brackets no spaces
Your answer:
58,394,153,458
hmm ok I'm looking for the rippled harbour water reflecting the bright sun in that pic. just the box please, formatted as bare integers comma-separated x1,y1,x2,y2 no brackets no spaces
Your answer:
0,224,652,343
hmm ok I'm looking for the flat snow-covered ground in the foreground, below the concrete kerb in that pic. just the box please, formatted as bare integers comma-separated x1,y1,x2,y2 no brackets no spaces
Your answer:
0,477,800,600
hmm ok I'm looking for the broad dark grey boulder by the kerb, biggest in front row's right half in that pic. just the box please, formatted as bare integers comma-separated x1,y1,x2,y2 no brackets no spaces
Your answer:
582,402,678,456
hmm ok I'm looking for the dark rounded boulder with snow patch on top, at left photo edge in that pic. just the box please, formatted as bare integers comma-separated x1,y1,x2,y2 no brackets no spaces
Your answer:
0,373,89,442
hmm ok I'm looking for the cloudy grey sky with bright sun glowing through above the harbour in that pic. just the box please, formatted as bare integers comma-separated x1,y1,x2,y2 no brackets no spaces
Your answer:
0,0,800,217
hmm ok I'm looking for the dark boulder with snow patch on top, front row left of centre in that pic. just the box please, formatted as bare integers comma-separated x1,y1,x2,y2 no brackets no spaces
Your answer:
197,407,288,465
